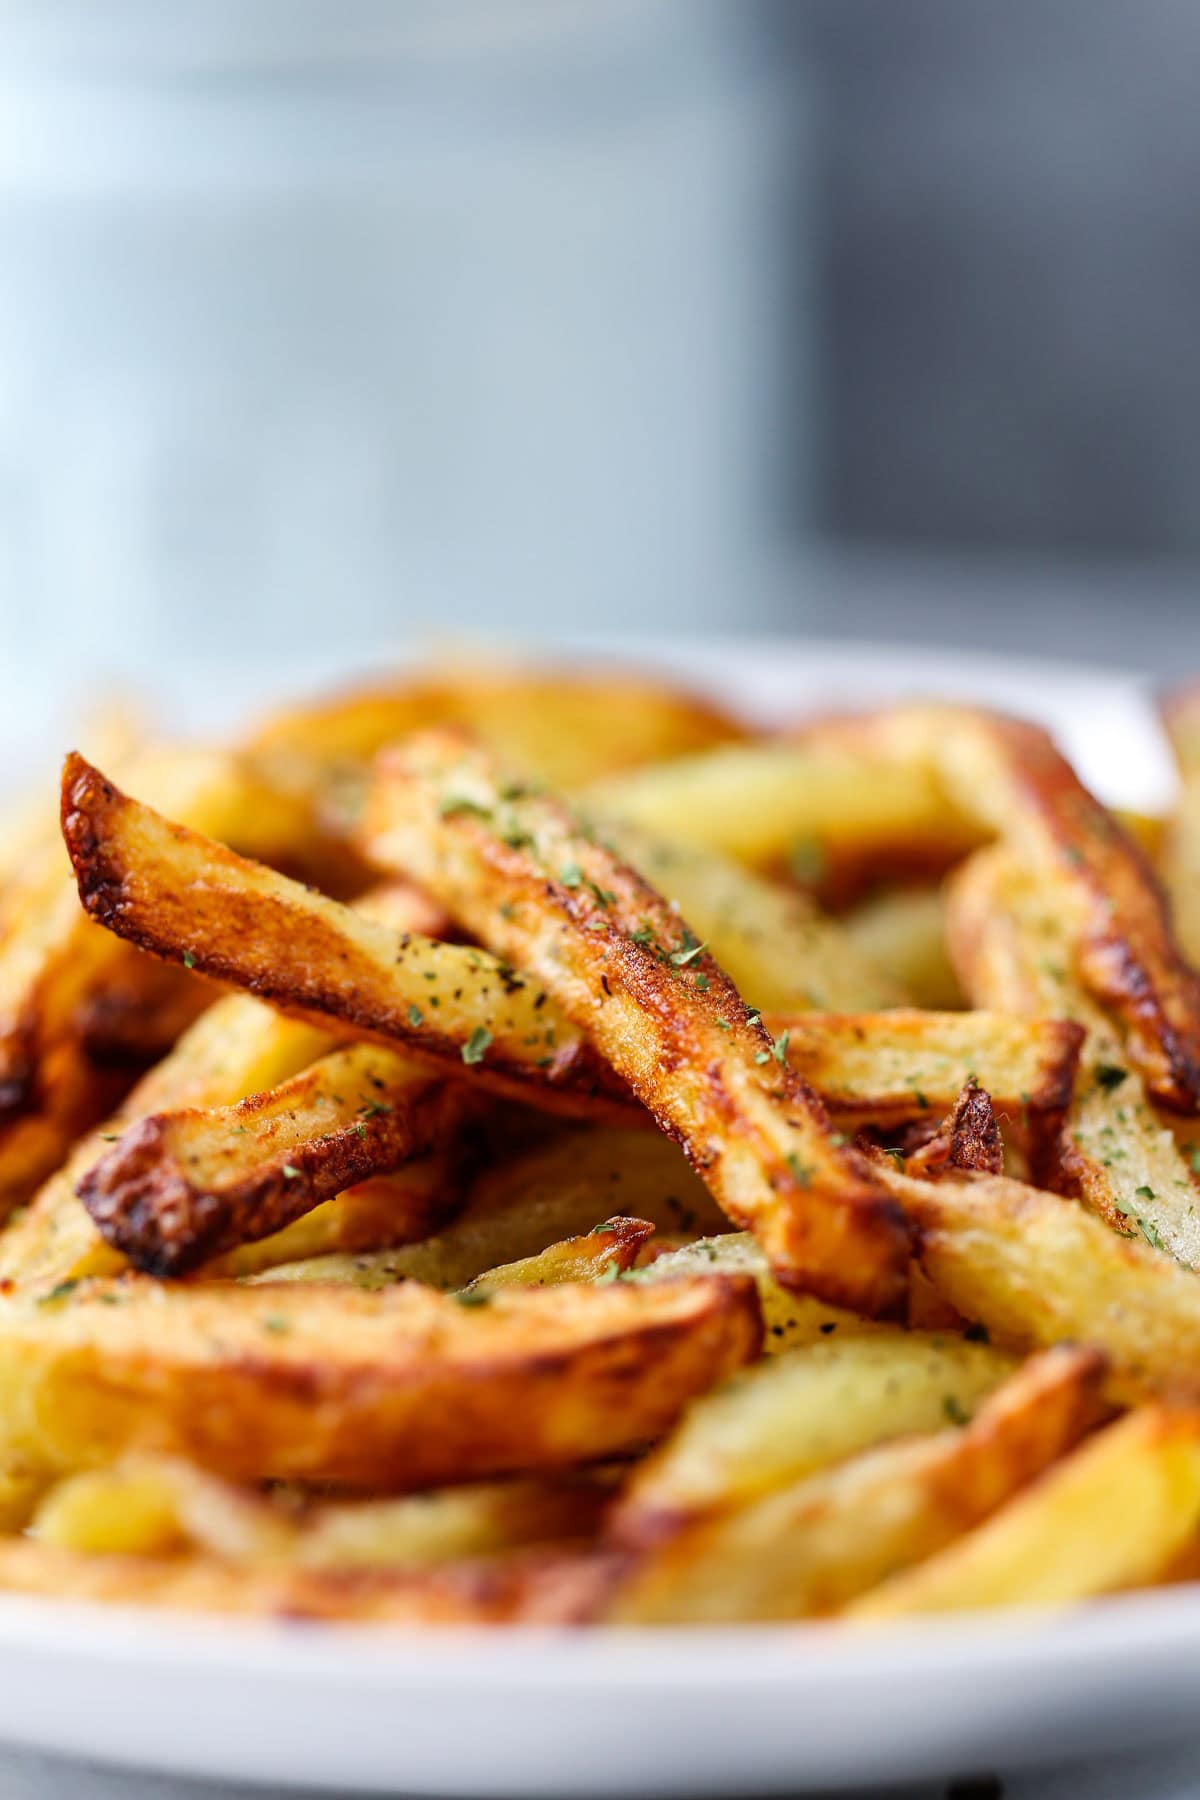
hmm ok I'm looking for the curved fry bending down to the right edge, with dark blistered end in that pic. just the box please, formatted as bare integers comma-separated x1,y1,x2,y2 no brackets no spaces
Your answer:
835,706,1200,1112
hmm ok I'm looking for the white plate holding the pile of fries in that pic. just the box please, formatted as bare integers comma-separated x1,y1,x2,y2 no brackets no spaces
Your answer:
0,643,1200,1800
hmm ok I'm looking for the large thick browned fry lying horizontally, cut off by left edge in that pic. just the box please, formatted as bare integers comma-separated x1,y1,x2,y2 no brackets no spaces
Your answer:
0,1276,761,1492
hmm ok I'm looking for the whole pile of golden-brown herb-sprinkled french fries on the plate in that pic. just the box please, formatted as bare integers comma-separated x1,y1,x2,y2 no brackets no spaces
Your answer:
0,668,1200,1629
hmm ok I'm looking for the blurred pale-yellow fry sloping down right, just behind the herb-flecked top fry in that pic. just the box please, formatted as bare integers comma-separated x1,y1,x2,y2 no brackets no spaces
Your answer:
603,824,905,1013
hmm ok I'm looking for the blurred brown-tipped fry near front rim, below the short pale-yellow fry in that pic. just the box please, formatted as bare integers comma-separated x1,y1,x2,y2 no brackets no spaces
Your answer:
612,1350,1101,1624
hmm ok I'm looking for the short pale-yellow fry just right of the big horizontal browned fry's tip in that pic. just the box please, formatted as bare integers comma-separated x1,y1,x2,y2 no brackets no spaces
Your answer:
613,1328,1013,1544
